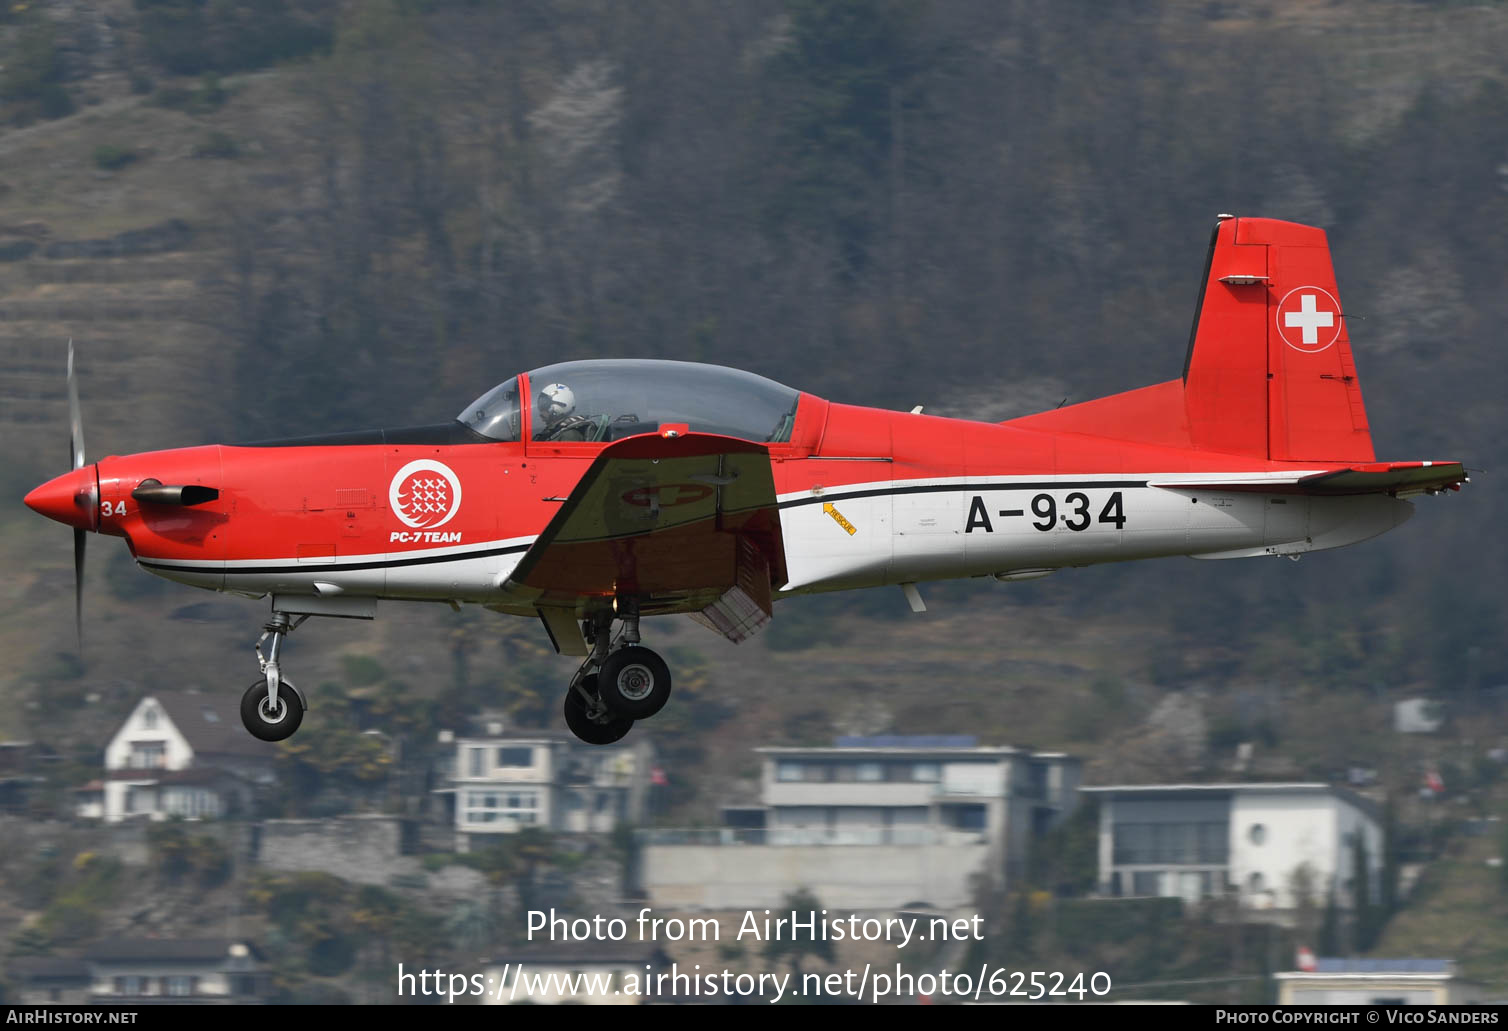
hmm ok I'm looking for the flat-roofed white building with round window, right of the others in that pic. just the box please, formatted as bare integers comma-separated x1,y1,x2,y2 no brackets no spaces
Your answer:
1083,784,1383,910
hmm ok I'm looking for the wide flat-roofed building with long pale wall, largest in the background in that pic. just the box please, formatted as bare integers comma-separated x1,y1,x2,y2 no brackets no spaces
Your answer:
641,736,1080,909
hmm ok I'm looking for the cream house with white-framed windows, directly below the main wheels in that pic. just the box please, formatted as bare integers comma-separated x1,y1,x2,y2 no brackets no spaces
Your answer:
439,733,653,849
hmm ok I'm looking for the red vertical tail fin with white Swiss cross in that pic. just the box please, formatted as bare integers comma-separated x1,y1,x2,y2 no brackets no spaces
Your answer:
1184,217,1372,461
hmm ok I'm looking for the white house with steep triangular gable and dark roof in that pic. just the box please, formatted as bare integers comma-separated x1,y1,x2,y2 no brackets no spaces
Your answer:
93,692,276,823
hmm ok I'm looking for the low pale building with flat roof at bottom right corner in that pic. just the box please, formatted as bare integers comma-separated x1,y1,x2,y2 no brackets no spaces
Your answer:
1273,959,1481,1005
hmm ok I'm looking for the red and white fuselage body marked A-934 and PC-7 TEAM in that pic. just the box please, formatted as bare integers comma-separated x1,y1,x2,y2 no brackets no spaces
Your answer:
50,393,1411,615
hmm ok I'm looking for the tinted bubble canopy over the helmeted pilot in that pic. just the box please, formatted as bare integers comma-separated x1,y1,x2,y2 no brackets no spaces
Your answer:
457,359,801,443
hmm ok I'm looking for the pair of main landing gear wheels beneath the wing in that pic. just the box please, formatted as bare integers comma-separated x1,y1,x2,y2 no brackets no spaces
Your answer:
566,598,670,745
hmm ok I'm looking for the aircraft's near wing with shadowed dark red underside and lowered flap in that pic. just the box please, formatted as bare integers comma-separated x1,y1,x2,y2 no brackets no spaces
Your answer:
504,433,786,651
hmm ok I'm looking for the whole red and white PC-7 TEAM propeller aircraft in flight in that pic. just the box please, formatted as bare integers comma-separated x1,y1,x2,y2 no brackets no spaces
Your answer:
26,216,1466,743
